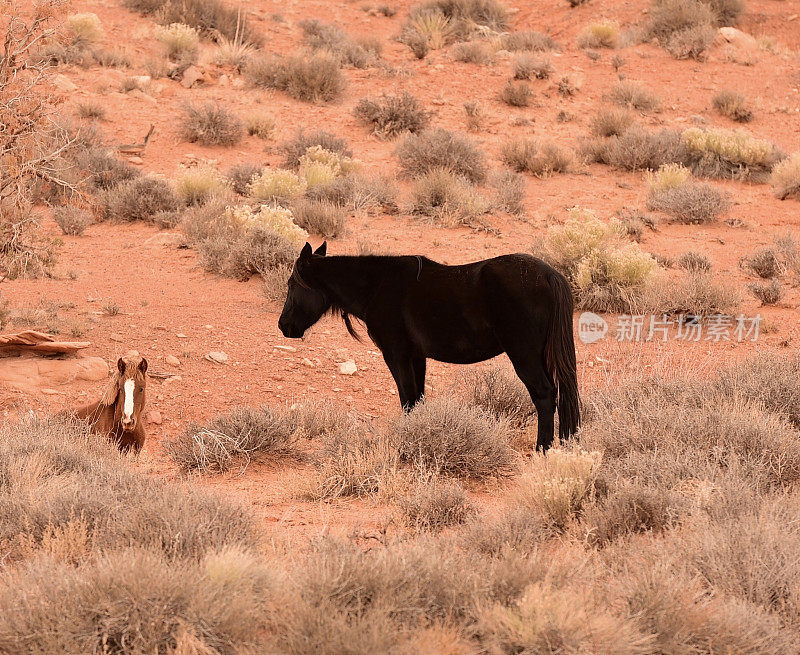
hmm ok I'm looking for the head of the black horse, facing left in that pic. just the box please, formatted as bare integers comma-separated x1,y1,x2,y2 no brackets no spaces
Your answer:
278,243,331,339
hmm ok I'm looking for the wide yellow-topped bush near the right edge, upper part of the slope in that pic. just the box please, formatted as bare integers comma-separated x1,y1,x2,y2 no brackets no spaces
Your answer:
681,127,783,182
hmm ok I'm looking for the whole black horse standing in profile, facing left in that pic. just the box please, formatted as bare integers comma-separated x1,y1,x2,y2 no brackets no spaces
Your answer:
278,243,580,450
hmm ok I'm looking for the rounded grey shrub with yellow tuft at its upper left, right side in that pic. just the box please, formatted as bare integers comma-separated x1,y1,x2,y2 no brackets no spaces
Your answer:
647,164,730,223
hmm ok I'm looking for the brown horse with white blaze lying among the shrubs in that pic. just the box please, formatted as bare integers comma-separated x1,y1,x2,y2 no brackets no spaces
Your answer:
66,354,147,453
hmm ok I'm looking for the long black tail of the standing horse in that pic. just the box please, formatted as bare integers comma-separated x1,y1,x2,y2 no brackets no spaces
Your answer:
544,271,581,441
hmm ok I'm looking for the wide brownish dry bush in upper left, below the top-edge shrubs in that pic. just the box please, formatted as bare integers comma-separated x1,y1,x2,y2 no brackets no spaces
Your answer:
244,52,347,102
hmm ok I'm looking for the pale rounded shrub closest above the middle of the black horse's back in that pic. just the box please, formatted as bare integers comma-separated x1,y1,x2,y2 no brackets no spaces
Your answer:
409,168,489,227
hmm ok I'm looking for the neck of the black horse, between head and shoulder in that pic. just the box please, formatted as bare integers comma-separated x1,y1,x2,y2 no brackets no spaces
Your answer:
318,256,408,319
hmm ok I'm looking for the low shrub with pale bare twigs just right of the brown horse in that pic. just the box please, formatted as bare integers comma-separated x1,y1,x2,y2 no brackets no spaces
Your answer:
164,406,295,471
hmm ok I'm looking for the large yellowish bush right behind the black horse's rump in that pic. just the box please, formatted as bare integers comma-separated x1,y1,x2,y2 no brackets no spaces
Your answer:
534,209,658,312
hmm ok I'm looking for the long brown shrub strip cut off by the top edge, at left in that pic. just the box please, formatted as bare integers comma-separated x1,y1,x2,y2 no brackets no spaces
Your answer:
123,0,264,46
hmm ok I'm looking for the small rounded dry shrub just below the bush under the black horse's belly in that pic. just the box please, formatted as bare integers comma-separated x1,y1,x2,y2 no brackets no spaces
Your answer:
397,477,474,532
